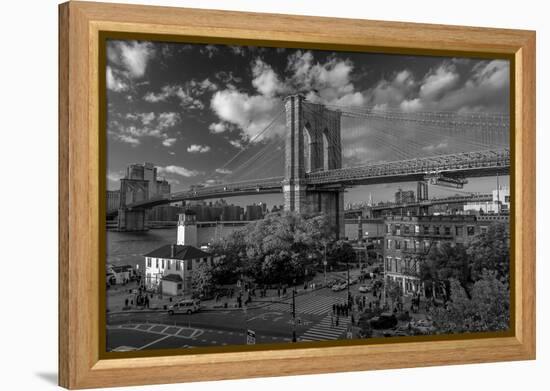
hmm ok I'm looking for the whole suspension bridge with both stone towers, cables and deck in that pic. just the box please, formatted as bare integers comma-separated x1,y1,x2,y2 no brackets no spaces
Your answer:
112,95,510,234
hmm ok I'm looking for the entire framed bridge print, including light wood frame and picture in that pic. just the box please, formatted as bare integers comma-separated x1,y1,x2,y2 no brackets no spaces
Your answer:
59,2,535,388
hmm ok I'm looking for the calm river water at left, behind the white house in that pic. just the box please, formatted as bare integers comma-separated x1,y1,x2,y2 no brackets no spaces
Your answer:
106,227,177,270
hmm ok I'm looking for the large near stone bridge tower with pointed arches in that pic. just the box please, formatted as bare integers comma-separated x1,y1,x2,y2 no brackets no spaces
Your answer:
283,95,344,238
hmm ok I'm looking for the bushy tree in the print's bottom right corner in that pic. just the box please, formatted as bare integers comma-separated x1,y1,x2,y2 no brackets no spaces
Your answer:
430,271,510,333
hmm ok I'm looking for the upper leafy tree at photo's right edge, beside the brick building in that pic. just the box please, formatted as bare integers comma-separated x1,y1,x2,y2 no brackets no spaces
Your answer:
468,222,510,282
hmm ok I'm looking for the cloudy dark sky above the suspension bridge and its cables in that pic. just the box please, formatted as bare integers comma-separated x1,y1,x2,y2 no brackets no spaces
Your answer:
106,41,509,203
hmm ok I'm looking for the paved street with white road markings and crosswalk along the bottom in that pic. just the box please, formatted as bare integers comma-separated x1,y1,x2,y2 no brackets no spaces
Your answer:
107,285,358,351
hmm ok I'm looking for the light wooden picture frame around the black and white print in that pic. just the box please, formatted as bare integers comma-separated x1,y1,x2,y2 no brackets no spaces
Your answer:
59,1,535,389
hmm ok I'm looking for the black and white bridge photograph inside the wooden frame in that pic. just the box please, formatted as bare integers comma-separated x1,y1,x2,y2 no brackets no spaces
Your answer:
102,39,514,352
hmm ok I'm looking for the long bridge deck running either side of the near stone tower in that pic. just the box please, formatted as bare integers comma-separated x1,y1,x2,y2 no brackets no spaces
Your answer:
126,149,510,209
